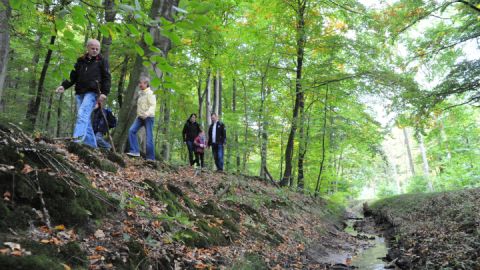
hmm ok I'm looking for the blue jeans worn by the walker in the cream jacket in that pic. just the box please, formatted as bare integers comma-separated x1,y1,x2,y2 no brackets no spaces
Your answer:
128,117,155,160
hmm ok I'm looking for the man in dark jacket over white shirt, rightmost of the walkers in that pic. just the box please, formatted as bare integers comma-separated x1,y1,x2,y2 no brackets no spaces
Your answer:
208,113,227,171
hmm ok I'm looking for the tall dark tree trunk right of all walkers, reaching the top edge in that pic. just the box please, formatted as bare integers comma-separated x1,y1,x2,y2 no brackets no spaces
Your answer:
280,0,306,186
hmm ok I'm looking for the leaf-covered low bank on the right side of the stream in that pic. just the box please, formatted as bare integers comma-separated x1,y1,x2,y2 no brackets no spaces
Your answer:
366,188,480,269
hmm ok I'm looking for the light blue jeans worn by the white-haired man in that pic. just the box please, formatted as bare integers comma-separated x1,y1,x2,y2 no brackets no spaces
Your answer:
73,92,97,148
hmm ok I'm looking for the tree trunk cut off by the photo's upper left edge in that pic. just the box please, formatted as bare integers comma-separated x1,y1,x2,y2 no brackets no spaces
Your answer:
0,0,12,104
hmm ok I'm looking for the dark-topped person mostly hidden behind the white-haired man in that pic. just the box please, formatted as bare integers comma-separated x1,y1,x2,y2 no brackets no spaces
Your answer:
93,100,117,149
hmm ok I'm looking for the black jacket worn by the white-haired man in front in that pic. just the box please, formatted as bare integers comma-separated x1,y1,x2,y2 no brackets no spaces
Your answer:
62,54,112,95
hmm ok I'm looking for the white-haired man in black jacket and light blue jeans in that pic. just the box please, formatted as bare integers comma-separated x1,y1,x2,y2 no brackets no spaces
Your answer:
56,39,111,148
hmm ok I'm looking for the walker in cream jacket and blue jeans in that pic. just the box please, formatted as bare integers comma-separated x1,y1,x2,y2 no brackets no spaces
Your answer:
127,77,157,160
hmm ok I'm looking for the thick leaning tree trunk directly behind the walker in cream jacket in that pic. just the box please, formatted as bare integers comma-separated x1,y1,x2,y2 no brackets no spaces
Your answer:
113,0,179,152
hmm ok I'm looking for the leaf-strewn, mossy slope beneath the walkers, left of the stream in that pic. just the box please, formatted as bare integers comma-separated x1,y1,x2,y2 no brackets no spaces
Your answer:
0,125,372,270
